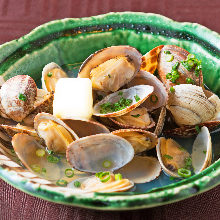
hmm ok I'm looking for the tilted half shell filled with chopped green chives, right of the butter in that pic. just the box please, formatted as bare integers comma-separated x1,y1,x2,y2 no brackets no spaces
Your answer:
93,85,154,117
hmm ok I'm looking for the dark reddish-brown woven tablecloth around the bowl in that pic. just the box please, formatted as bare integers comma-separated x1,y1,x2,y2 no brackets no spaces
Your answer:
0,0,220,220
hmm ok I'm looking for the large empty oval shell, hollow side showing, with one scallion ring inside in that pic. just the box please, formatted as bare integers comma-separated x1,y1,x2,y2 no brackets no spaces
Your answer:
66,134,134,173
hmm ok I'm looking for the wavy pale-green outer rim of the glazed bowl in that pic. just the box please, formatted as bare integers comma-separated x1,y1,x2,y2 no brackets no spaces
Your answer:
0,12,220,210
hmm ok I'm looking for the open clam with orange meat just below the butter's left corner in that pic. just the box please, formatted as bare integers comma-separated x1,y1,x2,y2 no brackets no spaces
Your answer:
34,113,78,153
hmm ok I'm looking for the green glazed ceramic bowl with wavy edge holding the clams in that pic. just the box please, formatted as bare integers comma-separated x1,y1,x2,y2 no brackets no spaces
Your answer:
0,12,220,210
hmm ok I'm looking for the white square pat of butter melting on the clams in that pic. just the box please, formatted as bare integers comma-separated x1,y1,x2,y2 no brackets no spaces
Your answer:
53,78,93,119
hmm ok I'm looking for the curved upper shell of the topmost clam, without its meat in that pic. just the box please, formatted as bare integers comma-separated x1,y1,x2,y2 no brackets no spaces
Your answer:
78,45,142,78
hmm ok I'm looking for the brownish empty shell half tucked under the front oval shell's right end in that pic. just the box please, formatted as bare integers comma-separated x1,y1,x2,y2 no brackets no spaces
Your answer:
118,156,161,183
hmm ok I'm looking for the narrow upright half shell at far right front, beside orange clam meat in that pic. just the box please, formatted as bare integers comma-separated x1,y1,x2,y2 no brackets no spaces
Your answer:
192,126,212,174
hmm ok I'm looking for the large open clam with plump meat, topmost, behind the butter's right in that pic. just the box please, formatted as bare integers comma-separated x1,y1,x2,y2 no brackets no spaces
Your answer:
78,46,141,92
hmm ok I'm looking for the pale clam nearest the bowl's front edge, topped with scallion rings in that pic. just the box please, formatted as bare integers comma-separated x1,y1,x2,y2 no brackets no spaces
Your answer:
68,173,134,193
